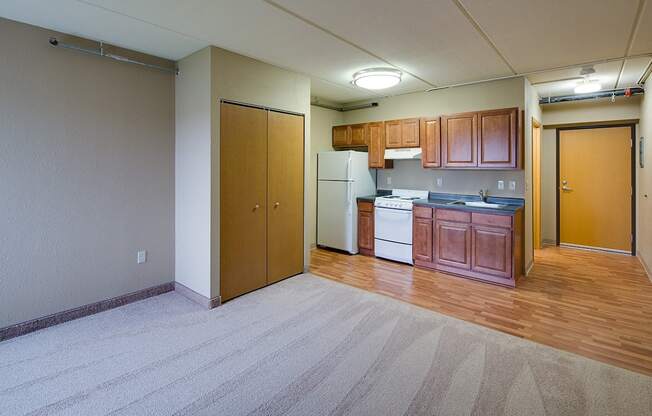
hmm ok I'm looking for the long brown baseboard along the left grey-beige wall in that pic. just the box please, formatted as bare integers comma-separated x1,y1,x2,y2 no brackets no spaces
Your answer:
0,282,174,341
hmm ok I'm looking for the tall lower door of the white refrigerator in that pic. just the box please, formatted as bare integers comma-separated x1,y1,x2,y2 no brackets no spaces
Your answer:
317,181,358,254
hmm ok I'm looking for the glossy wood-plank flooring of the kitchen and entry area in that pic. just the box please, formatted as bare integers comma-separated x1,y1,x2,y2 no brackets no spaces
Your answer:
310,247,652,375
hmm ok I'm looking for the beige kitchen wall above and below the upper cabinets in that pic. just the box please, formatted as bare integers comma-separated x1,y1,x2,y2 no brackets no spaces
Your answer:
344,78,525,197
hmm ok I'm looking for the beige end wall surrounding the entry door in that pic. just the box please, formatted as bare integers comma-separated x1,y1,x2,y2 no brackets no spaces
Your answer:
541,96,645,244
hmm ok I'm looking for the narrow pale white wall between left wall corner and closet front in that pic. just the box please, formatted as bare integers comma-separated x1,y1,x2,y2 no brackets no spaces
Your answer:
175,48,211,298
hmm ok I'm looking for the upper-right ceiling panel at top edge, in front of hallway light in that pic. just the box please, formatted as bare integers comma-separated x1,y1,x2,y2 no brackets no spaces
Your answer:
461,0,649,72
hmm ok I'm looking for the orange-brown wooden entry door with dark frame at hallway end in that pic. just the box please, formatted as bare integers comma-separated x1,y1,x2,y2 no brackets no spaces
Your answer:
557,125,636,255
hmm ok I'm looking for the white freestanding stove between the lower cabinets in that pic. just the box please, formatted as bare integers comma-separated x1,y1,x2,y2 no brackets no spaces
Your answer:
374,189,428,264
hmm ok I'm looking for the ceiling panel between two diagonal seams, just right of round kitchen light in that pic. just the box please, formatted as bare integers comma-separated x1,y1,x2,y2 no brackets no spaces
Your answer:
275,0,511,85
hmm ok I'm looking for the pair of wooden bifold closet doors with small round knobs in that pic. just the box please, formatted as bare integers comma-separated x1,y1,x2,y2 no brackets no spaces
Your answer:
220,103,304,301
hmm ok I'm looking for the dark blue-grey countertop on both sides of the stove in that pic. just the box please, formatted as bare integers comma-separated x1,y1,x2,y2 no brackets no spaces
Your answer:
358,190,525,215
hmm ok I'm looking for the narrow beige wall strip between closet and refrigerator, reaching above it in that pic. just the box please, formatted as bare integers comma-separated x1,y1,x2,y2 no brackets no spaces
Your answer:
306,105,344,247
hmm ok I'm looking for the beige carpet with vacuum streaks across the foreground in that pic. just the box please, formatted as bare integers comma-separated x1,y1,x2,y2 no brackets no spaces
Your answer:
0,275,652,416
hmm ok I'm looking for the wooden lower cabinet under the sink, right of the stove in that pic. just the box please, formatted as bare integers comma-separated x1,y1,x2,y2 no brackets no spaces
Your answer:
412,206,524,287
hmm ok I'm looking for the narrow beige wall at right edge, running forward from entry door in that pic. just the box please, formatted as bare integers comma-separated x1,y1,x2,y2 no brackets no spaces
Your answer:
637,90,652,274
